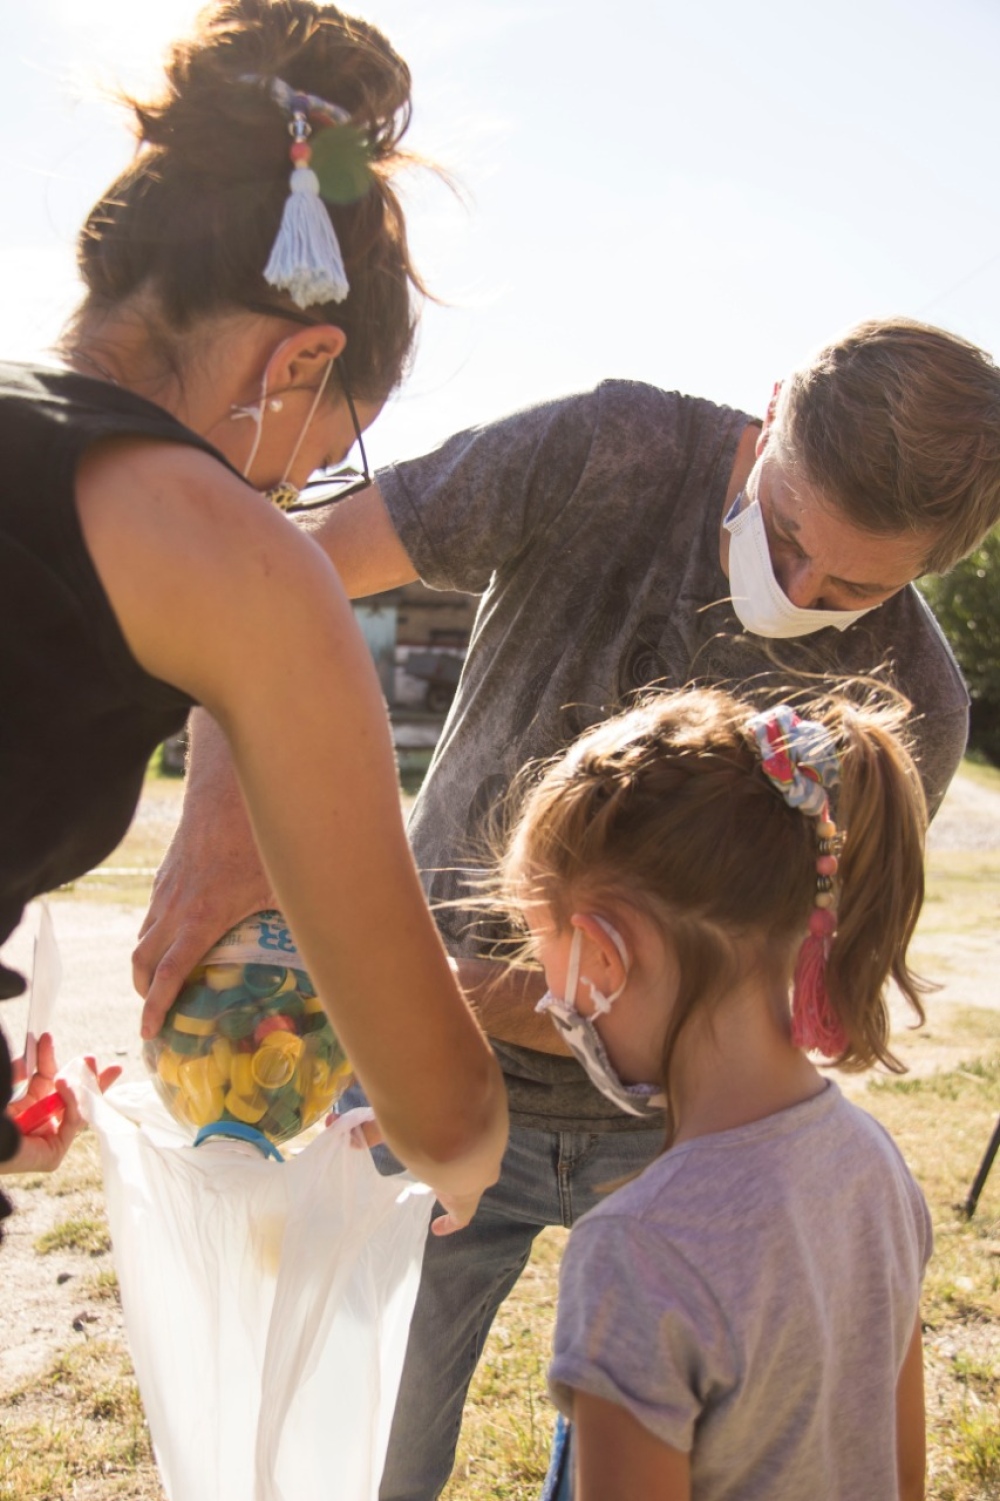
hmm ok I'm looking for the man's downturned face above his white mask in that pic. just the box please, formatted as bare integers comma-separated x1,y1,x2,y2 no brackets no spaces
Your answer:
746,446,934,609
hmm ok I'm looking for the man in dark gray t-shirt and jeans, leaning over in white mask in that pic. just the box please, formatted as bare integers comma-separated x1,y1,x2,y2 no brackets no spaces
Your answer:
135,310,1000,1501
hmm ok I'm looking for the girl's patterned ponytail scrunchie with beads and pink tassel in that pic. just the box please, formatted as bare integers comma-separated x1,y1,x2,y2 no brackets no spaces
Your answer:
748,704,850,1058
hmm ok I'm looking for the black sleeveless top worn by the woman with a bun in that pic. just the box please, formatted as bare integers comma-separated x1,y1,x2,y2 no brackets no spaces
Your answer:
0,365,235,954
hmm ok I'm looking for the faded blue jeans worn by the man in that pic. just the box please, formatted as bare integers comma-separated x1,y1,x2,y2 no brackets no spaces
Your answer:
341,1091,662,1501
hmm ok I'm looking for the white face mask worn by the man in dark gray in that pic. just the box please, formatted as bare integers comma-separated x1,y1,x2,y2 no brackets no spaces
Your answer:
722,491,877,639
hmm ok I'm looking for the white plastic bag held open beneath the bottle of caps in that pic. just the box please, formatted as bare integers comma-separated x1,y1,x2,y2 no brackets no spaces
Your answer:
74,1070,432,1501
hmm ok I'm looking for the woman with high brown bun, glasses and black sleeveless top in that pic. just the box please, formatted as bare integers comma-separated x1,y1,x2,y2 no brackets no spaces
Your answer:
0,0,506,1234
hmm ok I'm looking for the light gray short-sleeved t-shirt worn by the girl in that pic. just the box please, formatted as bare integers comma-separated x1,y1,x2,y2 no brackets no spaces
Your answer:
550,1084,932,1501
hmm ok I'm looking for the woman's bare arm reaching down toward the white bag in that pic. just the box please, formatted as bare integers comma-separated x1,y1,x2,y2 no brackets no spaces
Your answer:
78,441,506,1222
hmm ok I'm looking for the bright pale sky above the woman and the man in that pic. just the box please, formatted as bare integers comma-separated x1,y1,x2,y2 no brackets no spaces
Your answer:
0,0,1000,462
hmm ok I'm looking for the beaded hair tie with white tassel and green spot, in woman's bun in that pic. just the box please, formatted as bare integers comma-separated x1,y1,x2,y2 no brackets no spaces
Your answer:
240,74,369,308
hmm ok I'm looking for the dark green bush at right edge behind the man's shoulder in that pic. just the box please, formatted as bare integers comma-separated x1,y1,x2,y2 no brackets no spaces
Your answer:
920,527,1000,766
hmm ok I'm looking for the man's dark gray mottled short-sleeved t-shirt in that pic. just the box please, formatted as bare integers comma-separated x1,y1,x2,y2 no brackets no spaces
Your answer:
378,381,968,1130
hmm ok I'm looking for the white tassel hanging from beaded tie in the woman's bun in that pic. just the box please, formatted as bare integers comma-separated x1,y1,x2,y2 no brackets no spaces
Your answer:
240,74,350,308
